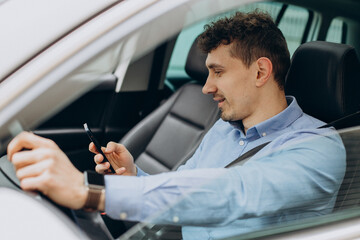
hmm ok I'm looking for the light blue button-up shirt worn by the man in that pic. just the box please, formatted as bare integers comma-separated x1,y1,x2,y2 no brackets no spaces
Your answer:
105,97,346,239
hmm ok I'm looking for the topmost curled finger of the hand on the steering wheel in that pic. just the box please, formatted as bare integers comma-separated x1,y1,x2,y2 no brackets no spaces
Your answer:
7,132,56,161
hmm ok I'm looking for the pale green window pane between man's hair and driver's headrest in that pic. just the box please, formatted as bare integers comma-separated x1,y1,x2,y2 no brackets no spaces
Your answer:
279,5,309,55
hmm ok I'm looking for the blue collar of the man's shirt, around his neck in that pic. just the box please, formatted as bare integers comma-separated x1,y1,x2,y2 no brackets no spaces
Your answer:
230,96,303,138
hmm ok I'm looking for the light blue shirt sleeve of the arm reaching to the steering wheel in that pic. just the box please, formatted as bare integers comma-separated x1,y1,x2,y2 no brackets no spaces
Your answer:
105,132,346,226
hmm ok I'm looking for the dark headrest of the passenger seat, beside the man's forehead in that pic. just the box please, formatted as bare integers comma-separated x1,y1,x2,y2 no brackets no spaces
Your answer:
185,39,209,84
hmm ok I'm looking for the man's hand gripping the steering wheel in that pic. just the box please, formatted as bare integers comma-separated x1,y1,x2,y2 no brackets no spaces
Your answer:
7,132,87,209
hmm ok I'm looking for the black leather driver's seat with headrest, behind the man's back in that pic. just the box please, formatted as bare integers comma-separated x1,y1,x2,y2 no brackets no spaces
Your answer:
285,42,360,210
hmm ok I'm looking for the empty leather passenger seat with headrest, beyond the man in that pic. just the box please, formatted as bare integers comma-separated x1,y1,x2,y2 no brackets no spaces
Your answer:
120,39,219,174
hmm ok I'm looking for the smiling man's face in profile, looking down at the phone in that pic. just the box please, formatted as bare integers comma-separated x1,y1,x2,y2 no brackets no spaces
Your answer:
202,44,258,121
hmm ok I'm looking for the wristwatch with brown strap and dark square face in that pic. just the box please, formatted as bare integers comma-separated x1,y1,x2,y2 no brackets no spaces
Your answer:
84,171,105,211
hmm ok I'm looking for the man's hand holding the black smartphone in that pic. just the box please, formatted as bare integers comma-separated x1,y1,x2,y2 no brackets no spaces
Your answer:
89,142,136,176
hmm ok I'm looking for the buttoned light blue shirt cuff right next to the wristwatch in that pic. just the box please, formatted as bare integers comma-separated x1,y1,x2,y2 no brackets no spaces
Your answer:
105,175,144,221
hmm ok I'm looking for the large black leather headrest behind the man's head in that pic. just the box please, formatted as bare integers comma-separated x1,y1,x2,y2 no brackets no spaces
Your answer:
285,41,360,122
